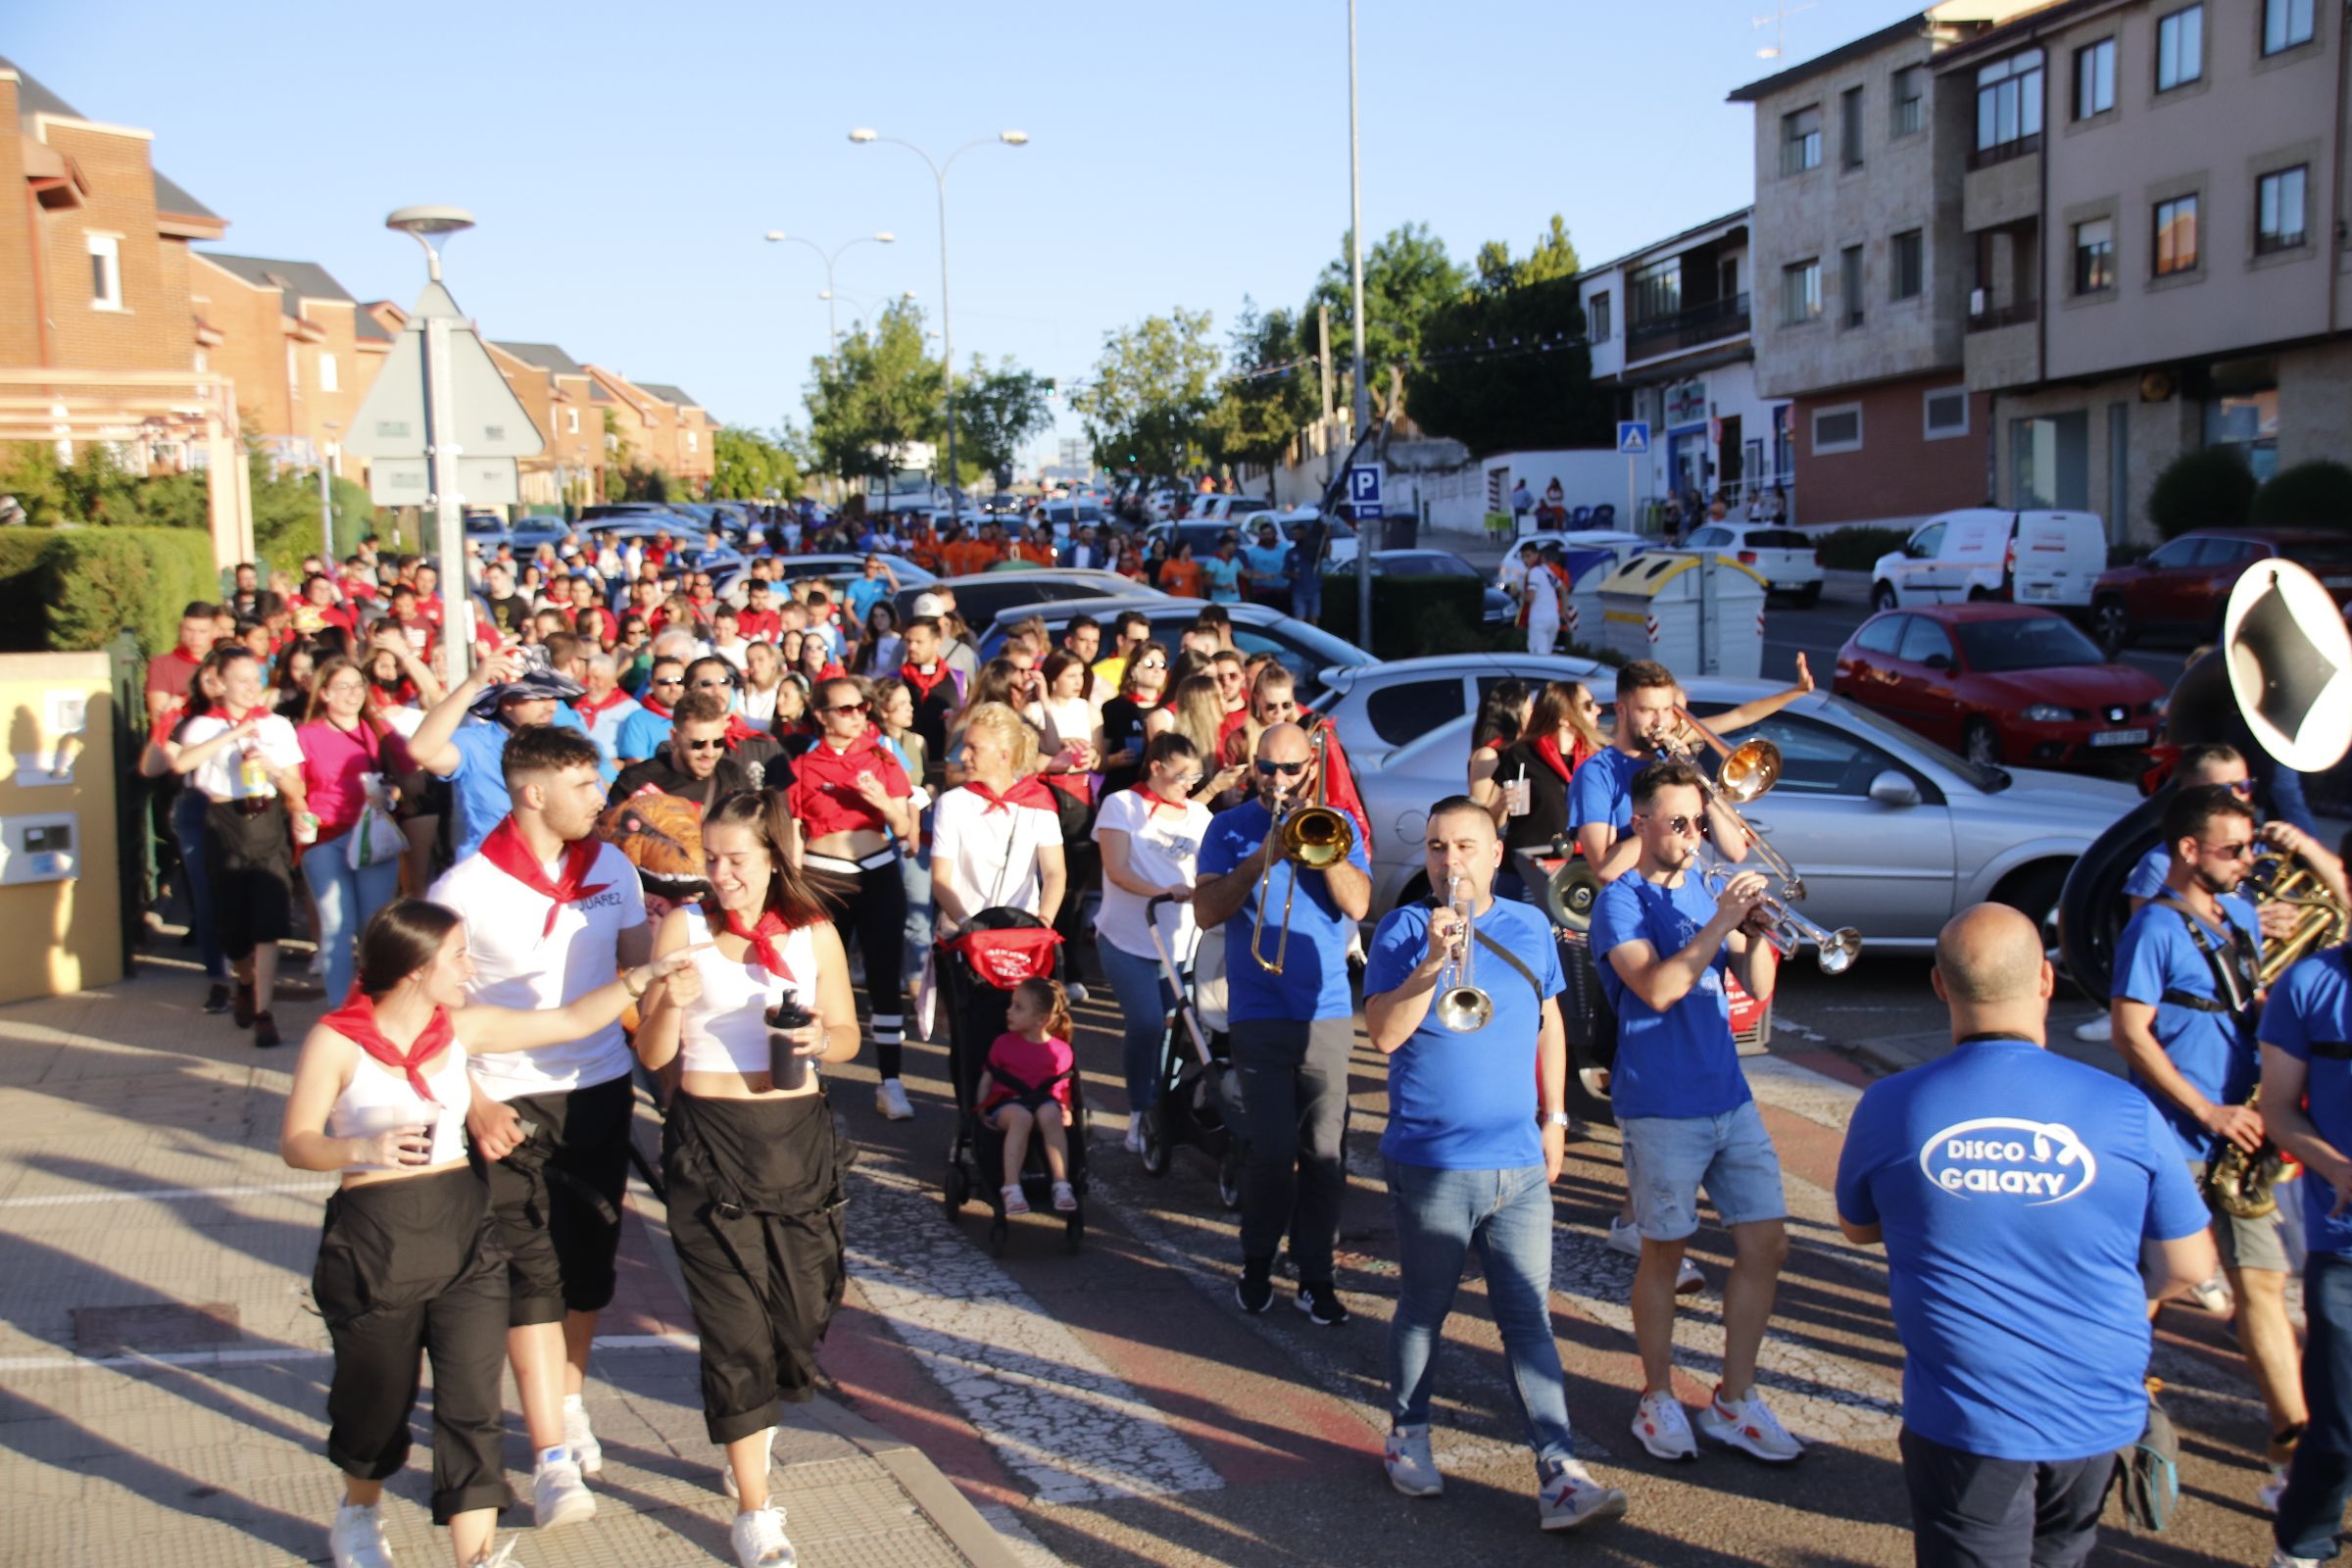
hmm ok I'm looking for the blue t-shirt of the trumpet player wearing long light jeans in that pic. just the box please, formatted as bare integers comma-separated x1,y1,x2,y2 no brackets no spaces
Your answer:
1364,898,1564,1171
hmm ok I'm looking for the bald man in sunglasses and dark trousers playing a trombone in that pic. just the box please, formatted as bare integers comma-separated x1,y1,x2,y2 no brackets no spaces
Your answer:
1193,724,1371,1326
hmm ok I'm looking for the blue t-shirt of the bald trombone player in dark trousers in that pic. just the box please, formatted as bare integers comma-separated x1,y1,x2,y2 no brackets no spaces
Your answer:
1200,800,1371,1022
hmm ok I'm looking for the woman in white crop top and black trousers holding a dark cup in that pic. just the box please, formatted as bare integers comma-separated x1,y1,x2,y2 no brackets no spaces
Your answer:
637,790,858,1563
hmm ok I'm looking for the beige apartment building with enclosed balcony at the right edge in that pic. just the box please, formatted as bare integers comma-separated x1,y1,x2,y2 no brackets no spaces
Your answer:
1936,0,2352,541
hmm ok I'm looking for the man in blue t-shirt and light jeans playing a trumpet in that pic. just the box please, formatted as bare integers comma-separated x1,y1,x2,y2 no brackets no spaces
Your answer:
1364,795,1625,1531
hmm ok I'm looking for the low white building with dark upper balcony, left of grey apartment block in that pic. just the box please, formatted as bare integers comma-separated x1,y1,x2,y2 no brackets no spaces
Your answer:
1576,207,1794,511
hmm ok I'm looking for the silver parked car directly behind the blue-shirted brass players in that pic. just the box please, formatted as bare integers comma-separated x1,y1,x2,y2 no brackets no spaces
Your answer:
1341,667,2140,964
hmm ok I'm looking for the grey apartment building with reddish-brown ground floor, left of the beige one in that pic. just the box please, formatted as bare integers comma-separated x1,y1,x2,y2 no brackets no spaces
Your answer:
1731,0,2030,522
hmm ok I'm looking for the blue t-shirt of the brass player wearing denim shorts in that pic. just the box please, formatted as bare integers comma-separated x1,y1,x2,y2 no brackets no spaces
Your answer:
1586,879,1752,1119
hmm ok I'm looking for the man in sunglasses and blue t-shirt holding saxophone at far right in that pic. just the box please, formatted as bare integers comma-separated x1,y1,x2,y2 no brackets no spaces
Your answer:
2112,785,2307,1504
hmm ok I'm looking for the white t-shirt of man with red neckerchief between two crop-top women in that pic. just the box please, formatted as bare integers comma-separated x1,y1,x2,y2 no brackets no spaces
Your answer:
425,844,645,1101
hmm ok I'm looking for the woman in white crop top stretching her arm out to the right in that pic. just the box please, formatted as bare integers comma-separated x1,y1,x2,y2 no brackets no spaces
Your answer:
277,898,694,1568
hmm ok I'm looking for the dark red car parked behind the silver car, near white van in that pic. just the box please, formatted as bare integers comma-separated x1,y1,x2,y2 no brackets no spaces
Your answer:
1833,602,2164,771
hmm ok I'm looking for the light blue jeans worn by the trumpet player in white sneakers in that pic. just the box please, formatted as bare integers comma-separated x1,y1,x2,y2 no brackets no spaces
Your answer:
1383,1159,1576,1464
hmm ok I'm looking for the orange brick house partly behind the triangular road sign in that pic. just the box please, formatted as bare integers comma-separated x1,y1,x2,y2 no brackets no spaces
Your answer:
188,252,393,472
